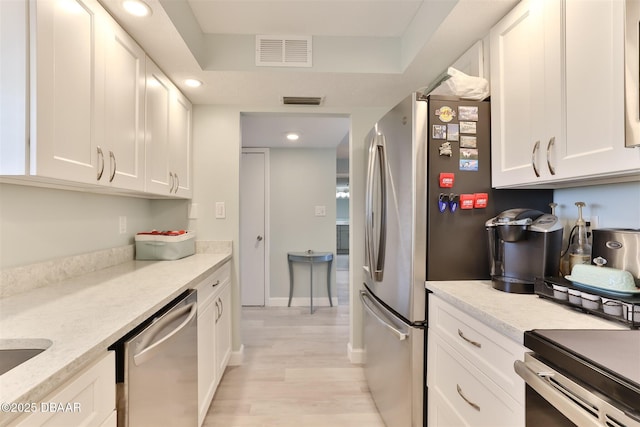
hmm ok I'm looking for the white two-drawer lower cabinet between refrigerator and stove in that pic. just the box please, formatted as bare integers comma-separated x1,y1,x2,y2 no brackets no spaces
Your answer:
427,295,525,427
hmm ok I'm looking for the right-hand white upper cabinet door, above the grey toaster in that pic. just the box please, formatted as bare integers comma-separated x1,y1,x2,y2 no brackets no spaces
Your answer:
554,0,640,178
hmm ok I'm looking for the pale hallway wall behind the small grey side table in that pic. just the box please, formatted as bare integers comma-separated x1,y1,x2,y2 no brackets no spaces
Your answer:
269,148,337,305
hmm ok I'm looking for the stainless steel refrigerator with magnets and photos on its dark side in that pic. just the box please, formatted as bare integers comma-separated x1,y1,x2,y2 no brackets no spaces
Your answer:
360,93,552,427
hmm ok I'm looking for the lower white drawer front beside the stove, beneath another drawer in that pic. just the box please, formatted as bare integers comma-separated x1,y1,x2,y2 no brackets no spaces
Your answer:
428,335,525,427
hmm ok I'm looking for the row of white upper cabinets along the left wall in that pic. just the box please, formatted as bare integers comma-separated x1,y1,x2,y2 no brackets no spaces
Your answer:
0,0,192,198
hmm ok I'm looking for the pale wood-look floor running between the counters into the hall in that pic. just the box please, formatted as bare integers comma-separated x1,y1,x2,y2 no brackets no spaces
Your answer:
204,306,384,427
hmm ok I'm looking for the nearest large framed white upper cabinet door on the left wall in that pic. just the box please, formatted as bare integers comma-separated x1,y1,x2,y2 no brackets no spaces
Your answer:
30,0,104,183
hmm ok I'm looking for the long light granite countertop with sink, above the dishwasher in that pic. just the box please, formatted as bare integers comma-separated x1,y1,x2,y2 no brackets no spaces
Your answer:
0,252,231,425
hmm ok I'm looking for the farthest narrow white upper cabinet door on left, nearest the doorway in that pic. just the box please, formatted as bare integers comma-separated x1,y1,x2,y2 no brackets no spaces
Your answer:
169,89,192,197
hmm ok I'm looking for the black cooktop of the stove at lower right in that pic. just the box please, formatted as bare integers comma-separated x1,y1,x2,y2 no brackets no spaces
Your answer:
524,329,640,412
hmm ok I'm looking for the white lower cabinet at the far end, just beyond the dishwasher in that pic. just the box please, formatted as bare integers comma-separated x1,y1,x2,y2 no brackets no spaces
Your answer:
196,262,231,425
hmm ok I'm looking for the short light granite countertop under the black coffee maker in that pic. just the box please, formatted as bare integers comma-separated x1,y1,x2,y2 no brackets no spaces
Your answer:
426,280,628,344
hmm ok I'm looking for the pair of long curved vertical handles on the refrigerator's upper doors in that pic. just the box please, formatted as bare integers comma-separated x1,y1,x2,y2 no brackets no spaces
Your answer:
365,133,387,282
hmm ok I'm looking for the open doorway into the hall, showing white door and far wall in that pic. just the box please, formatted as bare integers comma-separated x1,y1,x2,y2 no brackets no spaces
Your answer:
239,113,351,307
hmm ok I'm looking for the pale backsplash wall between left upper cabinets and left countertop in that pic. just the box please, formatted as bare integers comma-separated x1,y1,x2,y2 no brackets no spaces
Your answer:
0,184,187,268
